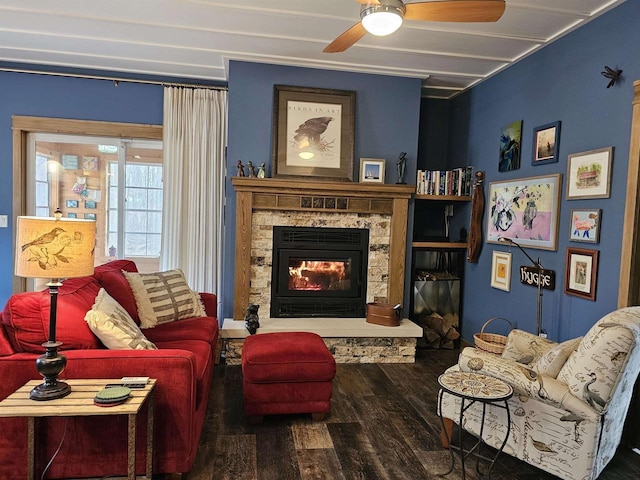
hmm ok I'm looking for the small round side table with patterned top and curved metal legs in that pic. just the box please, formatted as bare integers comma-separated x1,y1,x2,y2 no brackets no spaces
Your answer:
438,372,513,480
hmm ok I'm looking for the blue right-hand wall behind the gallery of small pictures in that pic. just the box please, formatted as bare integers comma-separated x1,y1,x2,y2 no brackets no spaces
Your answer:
448,0,640,341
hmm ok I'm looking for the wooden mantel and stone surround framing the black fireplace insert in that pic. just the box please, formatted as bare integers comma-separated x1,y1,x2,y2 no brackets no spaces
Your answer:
231,177,414,320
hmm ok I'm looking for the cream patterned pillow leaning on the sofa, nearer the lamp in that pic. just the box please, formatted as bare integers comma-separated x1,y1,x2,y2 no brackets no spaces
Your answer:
84,288,157,350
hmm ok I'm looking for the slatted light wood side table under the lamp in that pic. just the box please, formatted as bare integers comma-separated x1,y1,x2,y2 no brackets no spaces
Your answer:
0,379,156,480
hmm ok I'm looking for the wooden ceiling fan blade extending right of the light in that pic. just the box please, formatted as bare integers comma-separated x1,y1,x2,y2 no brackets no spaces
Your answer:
404,0,505,22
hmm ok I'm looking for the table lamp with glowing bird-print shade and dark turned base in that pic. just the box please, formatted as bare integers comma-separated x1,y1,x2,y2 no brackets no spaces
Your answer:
15,210,96,400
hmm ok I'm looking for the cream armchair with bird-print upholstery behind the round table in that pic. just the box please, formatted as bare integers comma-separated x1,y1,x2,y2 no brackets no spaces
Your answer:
440,307,640,480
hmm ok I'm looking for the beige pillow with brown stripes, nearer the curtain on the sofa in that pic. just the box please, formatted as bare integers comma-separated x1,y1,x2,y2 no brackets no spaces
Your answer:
122,269,206,328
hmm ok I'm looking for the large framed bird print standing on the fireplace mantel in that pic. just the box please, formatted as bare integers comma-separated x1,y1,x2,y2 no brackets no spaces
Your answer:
273,85,356,181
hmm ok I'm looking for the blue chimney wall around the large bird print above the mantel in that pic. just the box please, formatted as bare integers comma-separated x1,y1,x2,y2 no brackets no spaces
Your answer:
222,61,420,317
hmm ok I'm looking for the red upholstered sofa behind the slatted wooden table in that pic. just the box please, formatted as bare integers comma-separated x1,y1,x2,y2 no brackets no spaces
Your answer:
0,260,218,479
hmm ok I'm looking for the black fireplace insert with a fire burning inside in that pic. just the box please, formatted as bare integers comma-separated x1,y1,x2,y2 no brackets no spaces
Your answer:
271,226,369,318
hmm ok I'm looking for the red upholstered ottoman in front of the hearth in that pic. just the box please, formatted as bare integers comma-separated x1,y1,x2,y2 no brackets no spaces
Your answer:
242,332,336,422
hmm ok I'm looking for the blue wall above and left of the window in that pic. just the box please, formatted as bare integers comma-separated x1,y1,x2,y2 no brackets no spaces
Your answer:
0,72,162,308
